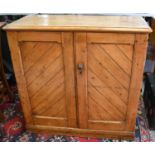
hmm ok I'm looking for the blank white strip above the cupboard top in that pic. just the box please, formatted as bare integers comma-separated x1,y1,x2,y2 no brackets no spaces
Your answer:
0,0,155,15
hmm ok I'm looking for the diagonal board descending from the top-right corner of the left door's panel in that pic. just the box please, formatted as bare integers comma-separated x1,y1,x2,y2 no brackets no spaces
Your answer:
25,44,61,85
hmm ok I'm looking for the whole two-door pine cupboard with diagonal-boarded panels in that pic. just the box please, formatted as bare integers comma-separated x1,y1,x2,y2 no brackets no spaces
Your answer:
4,15,151,138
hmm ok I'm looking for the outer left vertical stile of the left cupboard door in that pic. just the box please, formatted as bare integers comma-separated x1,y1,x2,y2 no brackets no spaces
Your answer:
7,31,33,123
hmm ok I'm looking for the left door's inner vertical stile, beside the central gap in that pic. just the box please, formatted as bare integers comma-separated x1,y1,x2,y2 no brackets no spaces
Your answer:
61,32,77,127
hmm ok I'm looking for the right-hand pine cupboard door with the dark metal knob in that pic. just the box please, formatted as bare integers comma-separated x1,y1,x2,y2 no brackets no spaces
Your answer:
75,33,146,131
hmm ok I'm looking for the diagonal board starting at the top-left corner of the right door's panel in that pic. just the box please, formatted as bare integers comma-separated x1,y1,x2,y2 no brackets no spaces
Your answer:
88,44,131,89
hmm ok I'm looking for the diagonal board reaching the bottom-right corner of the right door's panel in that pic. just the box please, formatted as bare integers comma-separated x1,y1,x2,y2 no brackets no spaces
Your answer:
88,84,125,121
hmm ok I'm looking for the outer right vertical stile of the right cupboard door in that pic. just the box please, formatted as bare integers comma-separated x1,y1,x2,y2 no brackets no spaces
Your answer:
126,34,148,131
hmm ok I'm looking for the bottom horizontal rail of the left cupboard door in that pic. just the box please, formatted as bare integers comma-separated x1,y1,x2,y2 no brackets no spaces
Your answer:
33,115,67,127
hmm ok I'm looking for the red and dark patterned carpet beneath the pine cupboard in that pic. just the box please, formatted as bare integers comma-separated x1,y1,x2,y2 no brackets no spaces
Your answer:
0,87,152,142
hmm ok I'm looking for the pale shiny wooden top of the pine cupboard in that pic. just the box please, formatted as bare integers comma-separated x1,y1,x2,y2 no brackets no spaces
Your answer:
4,15,151,32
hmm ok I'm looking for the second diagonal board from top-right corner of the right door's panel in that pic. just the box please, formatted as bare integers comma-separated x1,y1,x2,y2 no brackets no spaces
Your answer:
98,44,132,76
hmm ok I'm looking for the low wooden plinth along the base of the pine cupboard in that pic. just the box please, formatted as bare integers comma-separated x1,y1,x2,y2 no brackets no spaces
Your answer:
26,125,134,140
